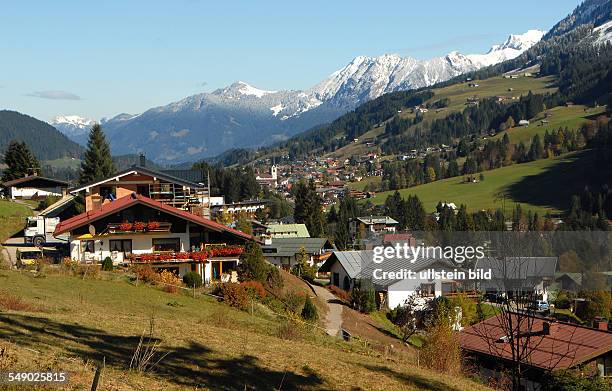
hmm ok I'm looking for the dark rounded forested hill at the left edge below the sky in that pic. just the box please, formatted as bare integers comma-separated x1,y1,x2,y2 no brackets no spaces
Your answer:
0,110,83,160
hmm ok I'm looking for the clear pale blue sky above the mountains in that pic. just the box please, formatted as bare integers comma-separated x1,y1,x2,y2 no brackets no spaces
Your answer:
0,0,579,121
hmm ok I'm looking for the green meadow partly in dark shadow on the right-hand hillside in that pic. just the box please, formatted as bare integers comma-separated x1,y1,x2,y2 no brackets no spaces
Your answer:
372,151,612,215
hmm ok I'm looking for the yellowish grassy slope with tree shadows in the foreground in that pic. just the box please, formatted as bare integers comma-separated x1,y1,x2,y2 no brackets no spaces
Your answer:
0,271,490,390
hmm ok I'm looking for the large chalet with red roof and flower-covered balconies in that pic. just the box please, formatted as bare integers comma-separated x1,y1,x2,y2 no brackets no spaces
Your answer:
54,193,253,283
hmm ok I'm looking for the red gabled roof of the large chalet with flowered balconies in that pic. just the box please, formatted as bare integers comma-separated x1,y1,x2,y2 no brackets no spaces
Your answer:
53,193,253,240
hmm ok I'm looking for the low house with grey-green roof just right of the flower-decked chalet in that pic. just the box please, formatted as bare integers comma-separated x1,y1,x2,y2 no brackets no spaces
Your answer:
261,238,336,269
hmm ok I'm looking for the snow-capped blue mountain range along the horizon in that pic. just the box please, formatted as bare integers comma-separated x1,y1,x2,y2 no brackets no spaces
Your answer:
51,30,545,163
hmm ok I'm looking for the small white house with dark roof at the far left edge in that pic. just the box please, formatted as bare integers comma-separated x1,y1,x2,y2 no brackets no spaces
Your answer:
2,175,69,200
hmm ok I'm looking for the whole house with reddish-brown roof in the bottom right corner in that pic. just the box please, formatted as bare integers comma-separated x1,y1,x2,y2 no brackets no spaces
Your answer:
459,314,612,390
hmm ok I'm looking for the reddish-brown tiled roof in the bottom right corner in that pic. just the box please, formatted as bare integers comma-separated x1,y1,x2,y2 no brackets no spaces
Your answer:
459,314,612,370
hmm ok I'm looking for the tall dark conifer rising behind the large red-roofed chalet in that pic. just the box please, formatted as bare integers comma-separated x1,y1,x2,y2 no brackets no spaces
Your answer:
79,124,115,184
